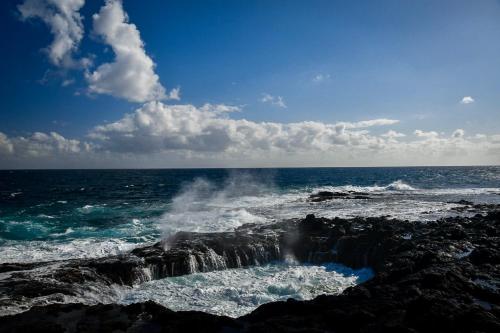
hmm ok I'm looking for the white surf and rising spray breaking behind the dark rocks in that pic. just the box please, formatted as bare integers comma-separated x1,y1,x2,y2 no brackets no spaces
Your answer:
161,179,500,235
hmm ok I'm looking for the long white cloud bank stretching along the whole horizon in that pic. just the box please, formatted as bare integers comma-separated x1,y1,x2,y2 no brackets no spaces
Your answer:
0,101,500,168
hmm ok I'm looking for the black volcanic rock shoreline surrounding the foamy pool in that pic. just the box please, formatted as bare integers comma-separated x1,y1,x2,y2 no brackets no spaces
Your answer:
0,204,500,332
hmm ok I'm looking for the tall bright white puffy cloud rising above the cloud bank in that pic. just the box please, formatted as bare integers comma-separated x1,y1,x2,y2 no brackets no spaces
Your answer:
86,0,170,102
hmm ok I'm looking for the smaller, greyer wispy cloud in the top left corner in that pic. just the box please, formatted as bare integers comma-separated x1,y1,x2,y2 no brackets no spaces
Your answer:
17,0,90,68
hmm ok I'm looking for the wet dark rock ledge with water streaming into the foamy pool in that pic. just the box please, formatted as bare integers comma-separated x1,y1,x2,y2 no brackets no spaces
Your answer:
0,222,290,311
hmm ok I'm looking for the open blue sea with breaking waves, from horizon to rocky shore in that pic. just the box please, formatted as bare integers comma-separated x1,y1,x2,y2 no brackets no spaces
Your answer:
0,166,500,261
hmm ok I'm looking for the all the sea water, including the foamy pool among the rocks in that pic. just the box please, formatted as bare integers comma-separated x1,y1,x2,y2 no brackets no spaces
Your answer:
0,166,500,316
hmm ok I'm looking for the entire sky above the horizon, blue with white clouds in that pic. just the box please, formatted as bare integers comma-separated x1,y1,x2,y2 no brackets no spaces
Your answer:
0,0,500,169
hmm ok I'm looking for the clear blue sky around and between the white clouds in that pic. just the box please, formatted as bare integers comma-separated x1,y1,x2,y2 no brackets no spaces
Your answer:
0,0,500,167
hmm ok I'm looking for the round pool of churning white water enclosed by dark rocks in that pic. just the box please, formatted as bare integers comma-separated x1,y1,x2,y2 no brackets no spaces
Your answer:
118,263,373,317
